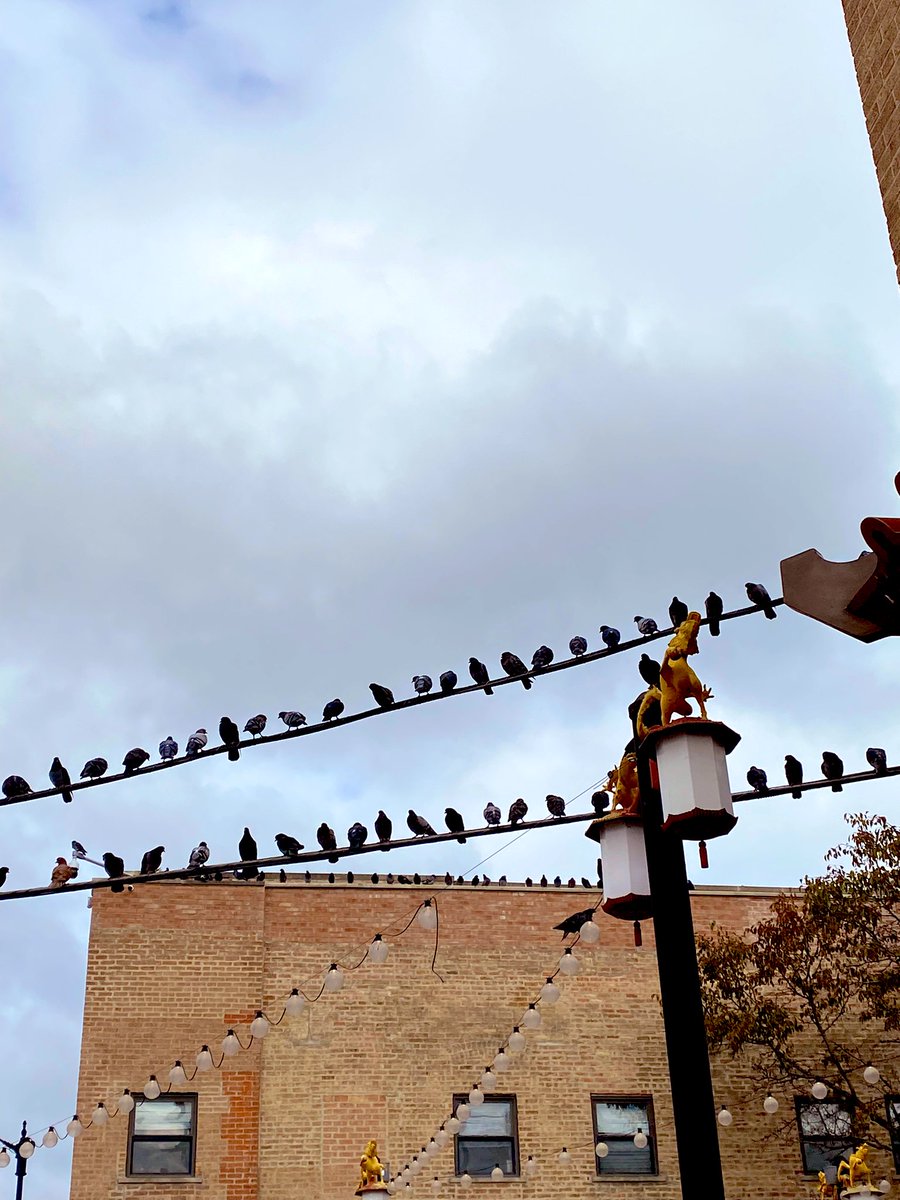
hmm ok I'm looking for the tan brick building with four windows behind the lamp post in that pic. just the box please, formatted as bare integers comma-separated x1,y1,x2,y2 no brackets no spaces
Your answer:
71,875,893,1200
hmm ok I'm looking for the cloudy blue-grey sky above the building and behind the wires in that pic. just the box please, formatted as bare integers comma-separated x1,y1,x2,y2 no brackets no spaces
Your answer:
0,0,900,1200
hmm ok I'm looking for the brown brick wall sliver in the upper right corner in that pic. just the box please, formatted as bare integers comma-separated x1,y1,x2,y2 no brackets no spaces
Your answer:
844,0,900,276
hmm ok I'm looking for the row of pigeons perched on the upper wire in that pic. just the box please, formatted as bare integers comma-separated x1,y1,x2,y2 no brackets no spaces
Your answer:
0,583,776,803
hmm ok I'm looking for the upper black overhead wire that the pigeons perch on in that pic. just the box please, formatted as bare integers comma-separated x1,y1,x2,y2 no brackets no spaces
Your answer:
0,598,785,806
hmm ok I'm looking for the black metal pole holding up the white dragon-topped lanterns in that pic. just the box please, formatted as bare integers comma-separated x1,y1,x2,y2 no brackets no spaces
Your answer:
637,748,725,1200
